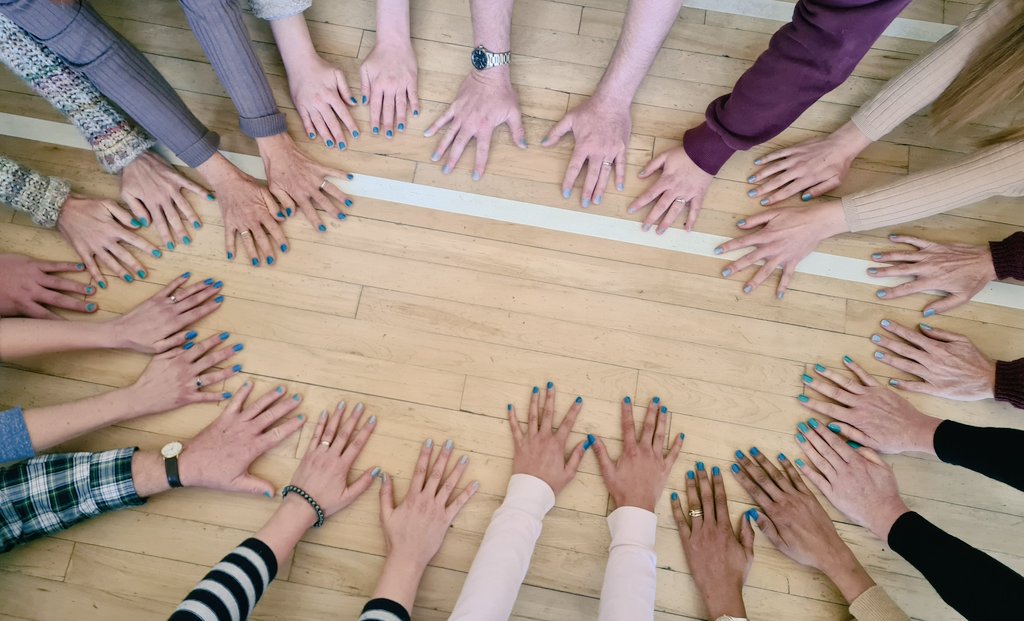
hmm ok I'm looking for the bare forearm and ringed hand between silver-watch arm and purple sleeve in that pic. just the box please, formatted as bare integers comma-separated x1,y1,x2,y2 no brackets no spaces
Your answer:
541,0,682,207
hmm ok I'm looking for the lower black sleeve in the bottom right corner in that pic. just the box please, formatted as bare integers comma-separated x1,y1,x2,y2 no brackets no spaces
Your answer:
889,511,1024,620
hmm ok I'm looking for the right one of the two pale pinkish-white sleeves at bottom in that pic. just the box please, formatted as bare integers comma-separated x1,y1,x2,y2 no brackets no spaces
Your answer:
598,506,657,621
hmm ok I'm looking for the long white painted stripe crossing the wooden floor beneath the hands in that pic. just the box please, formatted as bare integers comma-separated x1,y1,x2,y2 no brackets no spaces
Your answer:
0,113,1024,309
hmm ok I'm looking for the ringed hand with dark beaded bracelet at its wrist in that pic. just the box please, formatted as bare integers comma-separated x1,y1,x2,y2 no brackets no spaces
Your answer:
292,402,380,520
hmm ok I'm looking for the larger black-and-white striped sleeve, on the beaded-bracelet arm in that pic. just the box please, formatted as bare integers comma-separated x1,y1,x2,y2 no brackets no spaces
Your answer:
170,538,278,621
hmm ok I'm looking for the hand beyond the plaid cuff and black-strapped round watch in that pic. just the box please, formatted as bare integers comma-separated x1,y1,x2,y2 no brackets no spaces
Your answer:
178,381,305,498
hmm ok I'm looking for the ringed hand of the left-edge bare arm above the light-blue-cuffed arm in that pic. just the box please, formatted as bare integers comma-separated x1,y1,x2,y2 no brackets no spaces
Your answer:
108,272,223,354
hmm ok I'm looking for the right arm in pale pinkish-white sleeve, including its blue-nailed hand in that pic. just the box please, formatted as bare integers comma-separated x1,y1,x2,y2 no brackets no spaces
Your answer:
594,397,683,621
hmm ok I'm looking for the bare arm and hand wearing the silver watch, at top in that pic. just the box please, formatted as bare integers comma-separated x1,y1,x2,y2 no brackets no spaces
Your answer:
423,0,526,180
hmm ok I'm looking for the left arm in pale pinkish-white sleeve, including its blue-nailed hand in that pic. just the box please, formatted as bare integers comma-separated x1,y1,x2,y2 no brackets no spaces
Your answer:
450,383,587,621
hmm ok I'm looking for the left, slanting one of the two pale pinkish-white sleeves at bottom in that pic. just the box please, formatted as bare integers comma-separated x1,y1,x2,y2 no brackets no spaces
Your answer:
449,474,555,621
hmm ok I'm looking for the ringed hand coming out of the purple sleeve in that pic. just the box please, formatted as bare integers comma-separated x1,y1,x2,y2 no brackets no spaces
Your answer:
627,147,715,235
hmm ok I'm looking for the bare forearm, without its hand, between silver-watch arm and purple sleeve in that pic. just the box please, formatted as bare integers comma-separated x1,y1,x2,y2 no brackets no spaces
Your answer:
594,0,682,106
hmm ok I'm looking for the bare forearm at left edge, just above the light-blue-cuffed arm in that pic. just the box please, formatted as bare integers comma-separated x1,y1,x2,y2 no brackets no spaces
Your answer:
0,318,118,362
